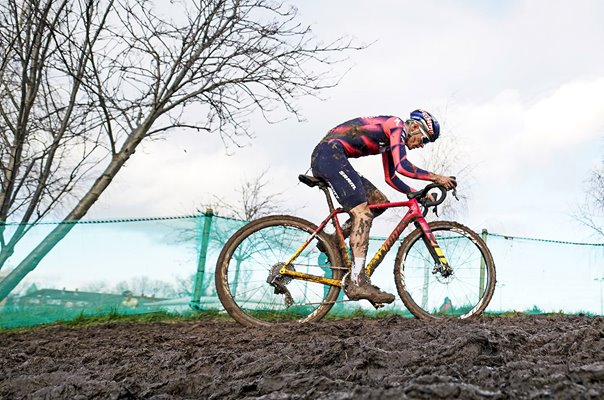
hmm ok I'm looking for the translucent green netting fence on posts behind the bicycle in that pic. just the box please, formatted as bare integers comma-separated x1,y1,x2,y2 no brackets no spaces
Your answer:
0,212,604,328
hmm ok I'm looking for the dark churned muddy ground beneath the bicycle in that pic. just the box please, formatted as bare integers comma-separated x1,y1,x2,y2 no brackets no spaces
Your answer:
0,316,604,399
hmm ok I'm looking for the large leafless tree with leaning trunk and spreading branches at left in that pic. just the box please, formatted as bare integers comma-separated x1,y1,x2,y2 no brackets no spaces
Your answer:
0,0,358,300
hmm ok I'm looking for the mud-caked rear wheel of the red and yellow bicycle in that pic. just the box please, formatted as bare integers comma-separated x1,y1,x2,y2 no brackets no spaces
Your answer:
215,215,345,326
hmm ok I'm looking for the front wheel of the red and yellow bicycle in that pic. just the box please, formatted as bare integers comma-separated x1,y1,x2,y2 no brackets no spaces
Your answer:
394,221,496,319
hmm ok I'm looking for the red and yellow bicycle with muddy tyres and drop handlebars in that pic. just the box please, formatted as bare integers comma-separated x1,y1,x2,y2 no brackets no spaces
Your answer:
215,175,495,326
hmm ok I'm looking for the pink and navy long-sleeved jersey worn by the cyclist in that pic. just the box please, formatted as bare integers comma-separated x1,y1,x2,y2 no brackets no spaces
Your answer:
322,115,430,193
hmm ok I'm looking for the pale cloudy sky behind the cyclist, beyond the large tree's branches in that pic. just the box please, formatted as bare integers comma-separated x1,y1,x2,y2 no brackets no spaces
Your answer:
89,0,604,242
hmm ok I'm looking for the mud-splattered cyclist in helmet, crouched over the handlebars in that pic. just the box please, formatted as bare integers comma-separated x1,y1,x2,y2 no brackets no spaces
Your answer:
311,110,457,303
